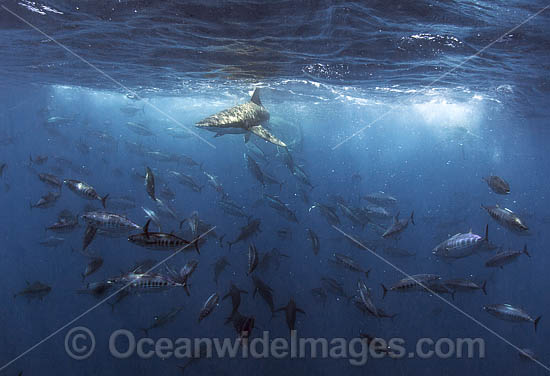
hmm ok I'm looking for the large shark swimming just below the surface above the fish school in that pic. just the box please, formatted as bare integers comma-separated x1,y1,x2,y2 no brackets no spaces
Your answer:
196,88,286,148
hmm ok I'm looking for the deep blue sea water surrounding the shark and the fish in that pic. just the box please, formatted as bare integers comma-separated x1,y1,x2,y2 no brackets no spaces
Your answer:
0,0,550,375
